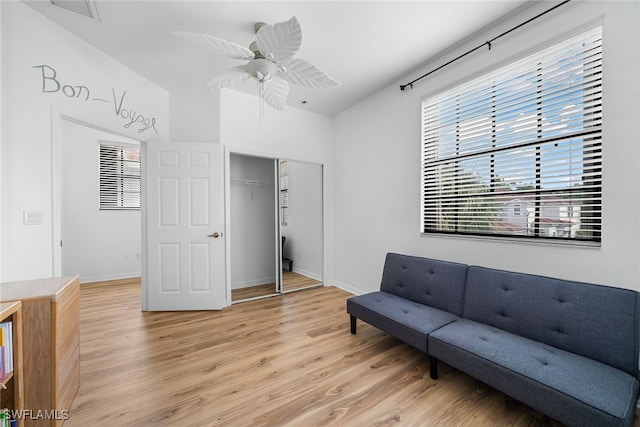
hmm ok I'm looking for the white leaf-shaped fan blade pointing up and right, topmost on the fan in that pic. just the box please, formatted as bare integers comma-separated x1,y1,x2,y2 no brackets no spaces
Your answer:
256,16,302,62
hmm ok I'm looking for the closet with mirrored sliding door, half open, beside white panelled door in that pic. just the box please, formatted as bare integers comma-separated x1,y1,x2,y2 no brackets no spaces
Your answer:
228,153,323,303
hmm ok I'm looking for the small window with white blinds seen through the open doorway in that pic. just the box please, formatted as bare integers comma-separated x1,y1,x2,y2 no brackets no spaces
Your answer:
100,142,141,210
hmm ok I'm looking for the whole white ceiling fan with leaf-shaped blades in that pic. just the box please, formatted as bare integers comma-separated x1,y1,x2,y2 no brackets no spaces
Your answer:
173,16,340,110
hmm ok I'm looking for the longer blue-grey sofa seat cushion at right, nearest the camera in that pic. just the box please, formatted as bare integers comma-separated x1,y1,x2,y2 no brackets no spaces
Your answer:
428,319,638,425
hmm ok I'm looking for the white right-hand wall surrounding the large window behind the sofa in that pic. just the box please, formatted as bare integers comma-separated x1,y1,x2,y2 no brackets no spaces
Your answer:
333,1,640,293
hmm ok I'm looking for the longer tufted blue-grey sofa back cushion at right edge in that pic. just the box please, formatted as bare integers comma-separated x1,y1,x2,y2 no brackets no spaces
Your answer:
463,266,639,376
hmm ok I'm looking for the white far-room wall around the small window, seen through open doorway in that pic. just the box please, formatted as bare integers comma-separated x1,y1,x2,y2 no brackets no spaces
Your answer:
62,120,142,283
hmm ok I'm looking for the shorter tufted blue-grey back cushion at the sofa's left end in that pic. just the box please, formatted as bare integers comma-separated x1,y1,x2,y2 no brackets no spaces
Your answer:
380,253,468,316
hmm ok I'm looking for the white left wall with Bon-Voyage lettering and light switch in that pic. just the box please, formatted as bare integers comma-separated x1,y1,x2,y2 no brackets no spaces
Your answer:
0,2,169,281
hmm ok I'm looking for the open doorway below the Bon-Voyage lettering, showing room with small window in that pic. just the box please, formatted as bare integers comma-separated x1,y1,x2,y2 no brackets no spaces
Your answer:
59,117,142,283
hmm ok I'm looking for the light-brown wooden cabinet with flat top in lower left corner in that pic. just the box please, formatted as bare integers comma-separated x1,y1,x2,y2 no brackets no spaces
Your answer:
0,276,80,426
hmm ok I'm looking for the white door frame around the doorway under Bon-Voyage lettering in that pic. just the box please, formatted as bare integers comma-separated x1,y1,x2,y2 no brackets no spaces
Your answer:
51,104,146,277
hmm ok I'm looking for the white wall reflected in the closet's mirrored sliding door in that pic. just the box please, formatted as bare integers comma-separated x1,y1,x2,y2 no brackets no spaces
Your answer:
281,160,323,280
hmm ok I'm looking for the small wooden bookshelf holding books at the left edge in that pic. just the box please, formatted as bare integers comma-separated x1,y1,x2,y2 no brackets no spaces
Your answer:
0,301,24,410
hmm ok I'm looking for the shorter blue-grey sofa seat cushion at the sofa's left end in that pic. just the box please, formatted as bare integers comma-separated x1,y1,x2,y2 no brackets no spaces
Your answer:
347,291,458,352
